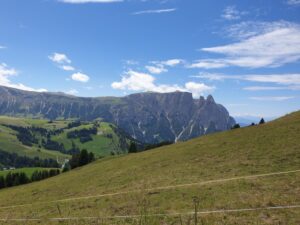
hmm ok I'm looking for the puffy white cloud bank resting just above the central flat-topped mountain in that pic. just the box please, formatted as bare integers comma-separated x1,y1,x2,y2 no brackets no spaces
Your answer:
111,70,215,98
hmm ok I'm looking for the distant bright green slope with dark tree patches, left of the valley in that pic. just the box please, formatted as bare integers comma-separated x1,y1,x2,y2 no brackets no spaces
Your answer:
0,116,129,159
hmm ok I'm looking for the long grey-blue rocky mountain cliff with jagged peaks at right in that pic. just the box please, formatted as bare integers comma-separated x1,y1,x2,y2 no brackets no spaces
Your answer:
0,87,235,143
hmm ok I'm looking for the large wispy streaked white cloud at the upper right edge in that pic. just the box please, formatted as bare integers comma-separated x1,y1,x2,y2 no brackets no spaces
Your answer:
192,22,300,69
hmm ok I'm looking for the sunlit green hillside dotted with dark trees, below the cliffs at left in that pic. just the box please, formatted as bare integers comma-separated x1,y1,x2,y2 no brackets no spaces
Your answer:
0,116,129,163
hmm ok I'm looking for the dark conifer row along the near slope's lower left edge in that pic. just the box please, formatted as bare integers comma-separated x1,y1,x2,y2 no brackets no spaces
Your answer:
0,169,60,189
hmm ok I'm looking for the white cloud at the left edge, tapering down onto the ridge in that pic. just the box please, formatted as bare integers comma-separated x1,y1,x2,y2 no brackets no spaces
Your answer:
0,63,47,92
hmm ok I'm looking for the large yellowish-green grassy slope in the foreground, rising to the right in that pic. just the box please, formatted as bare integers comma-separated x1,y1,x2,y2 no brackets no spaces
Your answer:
0,112,300,224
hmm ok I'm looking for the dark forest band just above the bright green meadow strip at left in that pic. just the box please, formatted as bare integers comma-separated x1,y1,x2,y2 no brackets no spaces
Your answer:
0,149,59,168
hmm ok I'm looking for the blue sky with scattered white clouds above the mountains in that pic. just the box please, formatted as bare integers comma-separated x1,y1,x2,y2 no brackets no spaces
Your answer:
0,0,300,117
